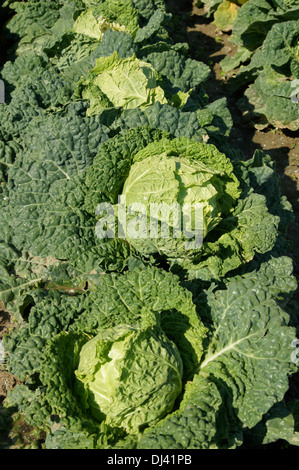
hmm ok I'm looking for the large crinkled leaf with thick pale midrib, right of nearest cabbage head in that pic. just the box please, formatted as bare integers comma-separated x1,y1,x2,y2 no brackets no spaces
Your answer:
200,264,294,428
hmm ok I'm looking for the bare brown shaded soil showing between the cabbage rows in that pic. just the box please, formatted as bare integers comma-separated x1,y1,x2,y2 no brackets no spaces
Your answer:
0,0,299,436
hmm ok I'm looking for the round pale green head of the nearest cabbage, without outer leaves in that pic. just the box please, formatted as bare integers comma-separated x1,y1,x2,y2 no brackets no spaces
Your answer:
75,314,183,433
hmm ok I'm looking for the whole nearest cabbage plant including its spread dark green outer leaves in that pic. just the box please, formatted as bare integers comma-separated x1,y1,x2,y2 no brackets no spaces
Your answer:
5,257,297,450
